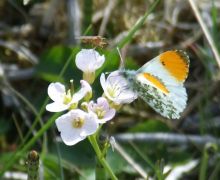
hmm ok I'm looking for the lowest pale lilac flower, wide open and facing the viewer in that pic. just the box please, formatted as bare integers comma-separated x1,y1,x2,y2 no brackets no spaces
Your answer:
56,109,98,146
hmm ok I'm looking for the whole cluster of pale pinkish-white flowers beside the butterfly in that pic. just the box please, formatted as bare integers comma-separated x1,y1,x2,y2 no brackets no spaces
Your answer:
46,49,137,145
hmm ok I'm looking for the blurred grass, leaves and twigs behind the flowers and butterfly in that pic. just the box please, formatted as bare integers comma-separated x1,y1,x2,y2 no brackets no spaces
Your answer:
0,0,220,180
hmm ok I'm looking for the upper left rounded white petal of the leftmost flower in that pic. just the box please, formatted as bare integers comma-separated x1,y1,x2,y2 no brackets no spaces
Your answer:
47,82,65,102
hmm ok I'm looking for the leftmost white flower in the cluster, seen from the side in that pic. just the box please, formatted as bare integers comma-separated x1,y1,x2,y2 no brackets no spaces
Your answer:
46,80,92,112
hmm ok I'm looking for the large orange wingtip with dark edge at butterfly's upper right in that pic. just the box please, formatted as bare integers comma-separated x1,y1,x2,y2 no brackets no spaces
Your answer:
159,50,189,82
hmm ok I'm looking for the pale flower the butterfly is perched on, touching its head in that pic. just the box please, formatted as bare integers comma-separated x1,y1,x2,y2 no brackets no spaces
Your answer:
100,71,137,104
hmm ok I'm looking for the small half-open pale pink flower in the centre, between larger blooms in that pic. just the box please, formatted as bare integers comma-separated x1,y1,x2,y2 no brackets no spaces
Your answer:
88,97,115,124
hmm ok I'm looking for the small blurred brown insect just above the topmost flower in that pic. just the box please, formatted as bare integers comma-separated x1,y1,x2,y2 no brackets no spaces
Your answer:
77,36,108,48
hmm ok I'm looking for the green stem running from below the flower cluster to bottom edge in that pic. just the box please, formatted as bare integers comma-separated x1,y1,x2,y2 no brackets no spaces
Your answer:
89,134,118,180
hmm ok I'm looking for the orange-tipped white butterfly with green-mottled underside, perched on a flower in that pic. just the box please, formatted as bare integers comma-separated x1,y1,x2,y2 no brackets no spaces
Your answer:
122,50,190,119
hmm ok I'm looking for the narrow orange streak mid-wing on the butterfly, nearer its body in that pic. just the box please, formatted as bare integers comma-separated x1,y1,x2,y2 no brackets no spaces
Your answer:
140,73,169,94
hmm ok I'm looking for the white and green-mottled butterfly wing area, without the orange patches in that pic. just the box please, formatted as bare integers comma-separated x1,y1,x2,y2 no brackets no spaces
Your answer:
130,56,187,119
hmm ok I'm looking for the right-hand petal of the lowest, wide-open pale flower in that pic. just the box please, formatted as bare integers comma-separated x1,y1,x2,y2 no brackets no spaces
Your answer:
80,113,99,136
